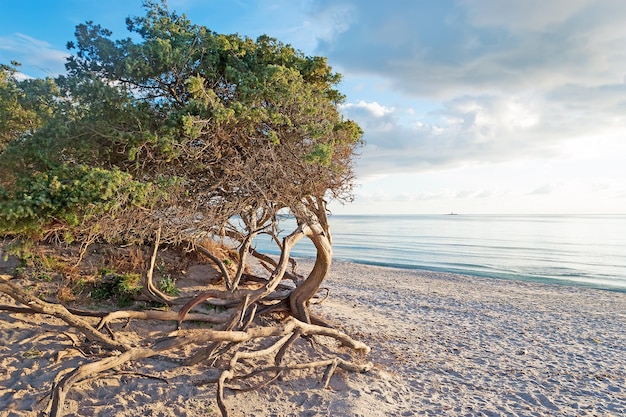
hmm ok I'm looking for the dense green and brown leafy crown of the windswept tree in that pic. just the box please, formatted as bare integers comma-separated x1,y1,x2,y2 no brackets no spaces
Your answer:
0,1,362,244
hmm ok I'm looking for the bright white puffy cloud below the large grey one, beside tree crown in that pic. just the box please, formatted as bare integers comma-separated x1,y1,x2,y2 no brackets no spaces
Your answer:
342,96,565,177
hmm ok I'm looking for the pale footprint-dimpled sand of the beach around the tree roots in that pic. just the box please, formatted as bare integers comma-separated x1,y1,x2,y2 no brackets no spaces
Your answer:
0,262,626,417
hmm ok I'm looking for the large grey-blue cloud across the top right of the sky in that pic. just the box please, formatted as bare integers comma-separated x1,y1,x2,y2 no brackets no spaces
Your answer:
315,0,626,99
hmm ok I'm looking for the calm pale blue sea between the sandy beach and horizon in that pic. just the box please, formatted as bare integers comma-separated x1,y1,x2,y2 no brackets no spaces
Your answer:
257,215,626,292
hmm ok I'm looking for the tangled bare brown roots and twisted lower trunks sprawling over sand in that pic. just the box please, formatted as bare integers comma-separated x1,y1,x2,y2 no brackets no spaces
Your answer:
0,218,372,417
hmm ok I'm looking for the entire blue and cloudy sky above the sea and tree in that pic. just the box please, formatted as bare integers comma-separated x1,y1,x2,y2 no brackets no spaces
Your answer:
0,0,626,214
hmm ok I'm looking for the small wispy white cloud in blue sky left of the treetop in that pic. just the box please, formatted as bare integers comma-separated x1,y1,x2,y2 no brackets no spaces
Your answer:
0,33,69,76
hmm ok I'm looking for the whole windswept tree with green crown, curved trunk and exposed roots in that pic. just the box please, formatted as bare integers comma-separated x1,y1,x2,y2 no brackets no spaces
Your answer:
0,2,367,414
